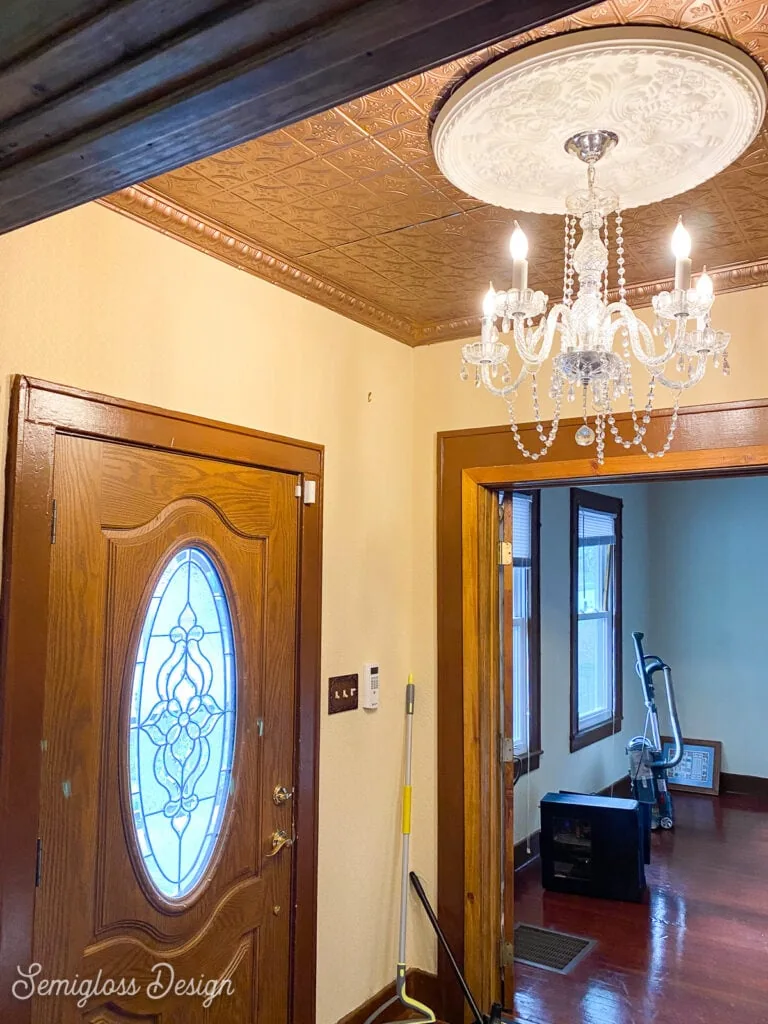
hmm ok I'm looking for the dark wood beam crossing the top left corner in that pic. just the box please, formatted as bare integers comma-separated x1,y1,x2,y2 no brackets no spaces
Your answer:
0,0,590,231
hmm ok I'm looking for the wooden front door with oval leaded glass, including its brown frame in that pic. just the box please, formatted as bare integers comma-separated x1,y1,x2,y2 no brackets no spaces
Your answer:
2,380,322,1024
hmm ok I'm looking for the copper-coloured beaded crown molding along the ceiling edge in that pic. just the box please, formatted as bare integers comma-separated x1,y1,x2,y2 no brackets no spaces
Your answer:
99,185,768,347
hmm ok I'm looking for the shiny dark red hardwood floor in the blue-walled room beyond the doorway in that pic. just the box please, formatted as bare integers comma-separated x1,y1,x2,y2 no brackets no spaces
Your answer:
515,795,768,1024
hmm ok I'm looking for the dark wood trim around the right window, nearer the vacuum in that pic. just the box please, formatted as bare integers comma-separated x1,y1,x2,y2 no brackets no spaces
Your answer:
570,487,624,754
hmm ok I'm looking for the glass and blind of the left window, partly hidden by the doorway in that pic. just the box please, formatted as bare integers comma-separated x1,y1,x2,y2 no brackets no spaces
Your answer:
512,492,534,755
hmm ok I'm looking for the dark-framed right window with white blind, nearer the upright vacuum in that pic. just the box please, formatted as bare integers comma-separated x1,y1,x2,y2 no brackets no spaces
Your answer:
571,490,622,745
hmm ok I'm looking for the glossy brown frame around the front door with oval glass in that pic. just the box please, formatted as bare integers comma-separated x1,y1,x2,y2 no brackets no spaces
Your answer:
0,376,324,1024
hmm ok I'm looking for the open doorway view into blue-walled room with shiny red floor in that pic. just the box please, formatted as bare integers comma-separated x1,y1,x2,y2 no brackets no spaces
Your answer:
502,475,768,1024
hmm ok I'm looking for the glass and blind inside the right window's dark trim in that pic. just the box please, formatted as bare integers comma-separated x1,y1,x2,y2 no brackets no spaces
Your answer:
575,507,616,730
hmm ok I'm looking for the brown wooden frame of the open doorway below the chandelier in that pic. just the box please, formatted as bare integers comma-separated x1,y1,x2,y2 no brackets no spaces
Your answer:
437,399,768,1020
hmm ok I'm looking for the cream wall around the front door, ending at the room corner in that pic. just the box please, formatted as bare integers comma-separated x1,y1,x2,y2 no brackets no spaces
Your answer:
0,205,433,1024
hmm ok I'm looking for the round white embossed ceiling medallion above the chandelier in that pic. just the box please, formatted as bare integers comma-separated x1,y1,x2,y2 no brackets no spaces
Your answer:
432,27,768,214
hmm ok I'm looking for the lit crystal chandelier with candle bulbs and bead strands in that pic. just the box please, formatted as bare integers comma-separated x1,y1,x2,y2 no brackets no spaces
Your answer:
462,131,730,465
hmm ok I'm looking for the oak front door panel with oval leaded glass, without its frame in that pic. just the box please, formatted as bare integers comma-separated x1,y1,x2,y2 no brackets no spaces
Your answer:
24,434,299,1024
